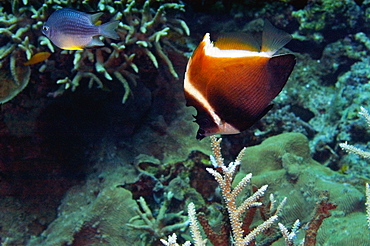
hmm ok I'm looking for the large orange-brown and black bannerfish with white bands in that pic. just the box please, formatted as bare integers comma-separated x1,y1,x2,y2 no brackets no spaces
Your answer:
184,21,296,139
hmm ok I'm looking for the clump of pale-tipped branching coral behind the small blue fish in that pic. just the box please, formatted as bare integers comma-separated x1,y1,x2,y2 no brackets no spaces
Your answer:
0,0,189,103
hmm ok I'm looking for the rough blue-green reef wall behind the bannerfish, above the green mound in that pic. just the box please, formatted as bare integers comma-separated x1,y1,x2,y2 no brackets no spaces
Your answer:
193,0,369,178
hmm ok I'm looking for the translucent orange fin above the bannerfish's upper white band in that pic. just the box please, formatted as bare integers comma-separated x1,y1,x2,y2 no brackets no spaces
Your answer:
214,33,261,51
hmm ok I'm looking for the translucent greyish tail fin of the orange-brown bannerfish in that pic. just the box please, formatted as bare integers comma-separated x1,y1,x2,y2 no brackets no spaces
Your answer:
261,20,292,55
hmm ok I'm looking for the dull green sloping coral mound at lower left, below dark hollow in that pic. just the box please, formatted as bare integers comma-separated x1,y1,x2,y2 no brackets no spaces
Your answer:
24,150,141,245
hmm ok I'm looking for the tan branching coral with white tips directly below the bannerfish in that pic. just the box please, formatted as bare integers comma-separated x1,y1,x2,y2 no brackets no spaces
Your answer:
165,136,286,246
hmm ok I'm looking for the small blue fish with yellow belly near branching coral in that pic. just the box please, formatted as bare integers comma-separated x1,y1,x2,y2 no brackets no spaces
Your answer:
42,8,119,50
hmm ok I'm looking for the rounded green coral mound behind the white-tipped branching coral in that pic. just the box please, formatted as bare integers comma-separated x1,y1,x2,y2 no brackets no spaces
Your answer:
235,133,369,245
